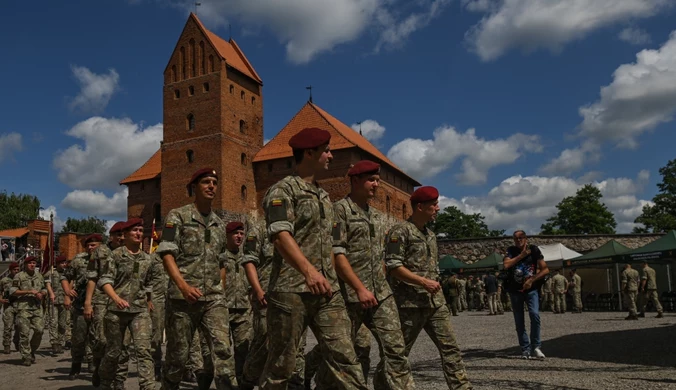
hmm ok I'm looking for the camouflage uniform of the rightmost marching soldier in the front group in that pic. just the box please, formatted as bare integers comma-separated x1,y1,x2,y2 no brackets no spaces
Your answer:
385,220,472,389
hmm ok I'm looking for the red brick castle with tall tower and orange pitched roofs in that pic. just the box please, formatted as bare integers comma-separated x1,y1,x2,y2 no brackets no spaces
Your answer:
120,14,420,232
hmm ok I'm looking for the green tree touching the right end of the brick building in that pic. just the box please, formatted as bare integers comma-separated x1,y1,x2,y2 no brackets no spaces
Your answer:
433,206,505,238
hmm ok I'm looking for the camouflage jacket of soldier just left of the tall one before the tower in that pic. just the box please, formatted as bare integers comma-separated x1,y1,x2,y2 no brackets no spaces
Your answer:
96,246,160,313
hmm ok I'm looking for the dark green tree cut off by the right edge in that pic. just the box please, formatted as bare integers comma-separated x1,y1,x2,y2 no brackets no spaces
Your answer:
634,159,676,233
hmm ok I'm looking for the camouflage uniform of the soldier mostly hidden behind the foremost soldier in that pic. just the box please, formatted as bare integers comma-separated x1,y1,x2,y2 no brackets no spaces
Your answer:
242,220,305,388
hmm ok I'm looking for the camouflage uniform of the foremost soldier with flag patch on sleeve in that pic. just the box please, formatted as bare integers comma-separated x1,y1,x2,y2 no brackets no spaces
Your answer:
261,176,367,389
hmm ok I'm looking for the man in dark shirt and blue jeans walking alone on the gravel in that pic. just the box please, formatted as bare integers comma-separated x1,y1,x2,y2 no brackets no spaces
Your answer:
503,230,549,359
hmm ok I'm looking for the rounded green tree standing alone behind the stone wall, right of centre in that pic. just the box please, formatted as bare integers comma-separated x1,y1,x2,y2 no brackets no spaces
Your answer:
540,184,617,234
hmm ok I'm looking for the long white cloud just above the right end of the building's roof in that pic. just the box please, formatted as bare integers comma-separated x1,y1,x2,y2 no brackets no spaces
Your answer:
387,127,542,184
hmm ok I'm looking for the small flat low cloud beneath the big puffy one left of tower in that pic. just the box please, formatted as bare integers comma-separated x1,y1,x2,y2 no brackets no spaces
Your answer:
61,188,129,218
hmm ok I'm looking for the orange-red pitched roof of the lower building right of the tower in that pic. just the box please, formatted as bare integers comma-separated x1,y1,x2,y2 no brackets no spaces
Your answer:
253,102,421,186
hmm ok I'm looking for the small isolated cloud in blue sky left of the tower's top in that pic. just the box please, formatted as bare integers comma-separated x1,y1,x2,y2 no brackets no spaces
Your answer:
70,65,120,113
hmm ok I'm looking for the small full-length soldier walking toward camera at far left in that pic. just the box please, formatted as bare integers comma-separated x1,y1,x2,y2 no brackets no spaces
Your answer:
9,257,47,366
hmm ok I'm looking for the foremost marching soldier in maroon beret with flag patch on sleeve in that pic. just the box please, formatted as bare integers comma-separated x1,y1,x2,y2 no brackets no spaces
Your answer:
261,128,367,390
